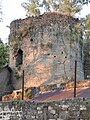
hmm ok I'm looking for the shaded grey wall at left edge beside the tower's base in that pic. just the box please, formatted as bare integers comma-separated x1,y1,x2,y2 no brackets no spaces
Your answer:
0,65,14,100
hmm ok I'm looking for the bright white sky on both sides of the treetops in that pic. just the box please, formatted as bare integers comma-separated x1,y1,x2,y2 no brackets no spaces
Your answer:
0,0,90,43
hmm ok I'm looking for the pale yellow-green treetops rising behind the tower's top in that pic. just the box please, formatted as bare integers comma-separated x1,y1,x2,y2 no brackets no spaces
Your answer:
22,0,81,16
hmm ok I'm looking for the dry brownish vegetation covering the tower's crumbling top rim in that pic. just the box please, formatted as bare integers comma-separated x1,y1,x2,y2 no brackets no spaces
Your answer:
9,12,82,51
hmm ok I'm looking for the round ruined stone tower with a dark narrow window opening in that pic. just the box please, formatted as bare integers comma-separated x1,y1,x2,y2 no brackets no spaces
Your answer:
9,13,84,87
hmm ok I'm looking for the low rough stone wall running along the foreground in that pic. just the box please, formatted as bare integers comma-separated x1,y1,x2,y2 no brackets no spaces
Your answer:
0,98,90,120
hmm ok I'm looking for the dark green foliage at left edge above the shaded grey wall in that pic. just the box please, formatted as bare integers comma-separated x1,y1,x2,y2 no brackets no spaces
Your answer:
0,44,9,69
